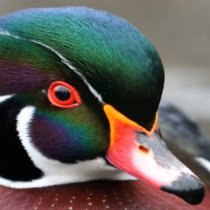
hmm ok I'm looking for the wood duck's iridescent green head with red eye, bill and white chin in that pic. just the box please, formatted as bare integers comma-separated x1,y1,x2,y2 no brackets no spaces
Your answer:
0,7,205,204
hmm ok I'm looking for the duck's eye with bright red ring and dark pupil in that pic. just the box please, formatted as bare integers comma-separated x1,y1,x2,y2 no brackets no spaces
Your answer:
48,81,81,108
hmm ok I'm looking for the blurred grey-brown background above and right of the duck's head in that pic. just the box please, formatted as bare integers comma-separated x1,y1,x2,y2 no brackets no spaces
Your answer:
0,0,210,136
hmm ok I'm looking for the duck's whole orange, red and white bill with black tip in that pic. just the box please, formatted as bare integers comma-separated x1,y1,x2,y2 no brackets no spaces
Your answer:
104,104,205,204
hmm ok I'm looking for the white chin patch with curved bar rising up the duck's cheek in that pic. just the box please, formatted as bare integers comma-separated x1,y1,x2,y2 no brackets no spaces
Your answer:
0,106,136,188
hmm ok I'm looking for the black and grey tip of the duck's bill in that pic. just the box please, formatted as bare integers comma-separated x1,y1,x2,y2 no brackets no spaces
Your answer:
161,174,205,205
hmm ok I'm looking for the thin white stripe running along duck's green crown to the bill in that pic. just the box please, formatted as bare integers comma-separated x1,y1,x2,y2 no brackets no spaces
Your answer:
0,28,103,103
